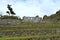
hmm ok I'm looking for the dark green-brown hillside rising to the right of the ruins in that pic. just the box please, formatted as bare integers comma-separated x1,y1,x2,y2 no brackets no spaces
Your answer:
43,10,60,21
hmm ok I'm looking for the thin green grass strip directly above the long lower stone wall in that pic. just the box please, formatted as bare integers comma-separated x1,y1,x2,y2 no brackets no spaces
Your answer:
0,27,60,32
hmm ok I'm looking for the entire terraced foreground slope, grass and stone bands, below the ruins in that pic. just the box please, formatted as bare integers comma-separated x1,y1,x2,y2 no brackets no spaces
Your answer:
0,22,60,40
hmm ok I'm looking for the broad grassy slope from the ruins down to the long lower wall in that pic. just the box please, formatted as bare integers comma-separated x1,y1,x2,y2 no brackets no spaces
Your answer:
0,22,60,32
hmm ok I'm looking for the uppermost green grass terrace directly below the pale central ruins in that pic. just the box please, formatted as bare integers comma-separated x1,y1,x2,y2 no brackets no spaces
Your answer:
2,22,60,28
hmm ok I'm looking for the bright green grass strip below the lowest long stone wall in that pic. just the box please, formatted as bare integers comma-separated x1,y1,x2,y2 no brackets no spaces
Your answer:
0,34,60,40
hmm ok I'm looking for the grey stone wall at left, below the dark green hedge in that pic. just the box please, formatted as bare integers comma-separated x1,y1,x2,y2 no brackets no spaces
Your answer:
0,19,21,25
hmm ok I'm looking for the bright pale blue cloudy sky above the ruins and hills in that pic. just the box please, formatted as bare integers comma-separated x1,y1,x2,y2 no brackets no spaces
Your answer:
0,0,60,18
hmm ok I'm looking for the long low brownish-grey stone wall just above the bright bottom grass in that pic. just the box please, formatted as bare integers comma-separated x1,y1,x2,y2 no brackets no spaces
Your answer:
0,30,60,37
